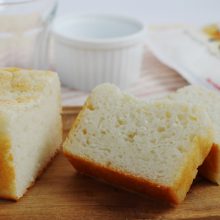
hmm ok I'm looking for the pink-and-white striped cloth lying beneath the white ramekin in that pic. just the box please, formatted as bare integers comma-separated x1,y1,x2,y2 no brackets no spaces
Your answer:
62,49,188,106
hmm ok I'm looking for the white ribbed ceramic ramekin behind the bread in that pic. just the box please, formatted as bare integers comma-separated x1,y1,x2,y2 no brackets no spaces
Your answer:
53,15,145,91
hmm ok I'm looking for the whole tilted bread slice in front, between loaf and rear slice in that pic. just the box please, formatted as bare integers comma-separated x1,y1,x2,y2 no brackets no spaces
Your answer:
63,84,213,204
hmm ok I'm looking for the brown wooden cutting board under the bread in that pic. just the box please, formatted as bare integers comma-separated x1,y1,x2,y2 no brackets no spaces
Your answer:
0,107,220,220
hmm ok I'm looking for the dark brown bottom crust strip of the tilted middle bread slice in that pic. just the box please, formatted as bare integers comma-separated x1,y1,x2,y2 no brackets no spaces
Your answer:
65,153,180,204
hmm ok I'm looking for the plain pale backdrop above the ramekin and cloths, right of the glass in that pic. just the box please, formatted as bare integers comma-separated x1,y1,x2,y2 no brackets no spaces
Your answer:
58,0,220,24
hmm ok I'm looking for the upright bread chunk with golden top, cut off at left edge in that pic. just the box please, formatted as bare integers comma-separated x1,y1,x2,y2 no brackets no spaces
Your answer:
0,68,62,200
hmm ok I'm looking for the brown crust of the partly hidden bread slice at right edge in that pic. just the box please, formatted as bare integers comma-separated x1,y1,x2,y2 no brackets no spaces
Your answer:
199,143,220,185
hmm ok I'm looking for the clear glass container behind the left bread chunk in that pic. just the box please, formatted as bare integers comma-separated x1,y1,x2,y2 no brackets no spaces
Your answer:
0,0,57,69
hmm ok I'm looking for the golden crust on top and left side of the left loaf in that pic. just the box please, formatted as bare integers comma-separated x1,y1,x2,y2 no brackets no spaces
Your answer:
0,67,60,200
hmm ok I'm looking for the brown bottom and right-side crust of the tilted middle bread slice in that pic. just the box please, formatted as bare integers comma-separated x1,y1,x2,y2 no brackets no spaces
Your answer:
64,132,211,205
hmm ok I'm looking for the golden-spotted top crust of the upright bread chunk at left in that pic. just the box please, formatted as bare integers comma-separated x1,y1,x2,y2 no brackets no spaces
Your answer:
0,67,58,105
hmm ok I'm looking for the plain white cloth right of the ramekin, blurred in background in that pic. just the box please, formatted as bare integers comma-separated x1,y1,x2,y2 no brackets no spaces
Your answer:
148,26,220,90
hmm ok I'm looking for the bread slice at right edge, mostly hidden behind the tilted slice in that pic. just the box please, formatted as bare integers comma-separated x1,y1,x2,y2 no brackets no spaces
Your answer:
165,86,220,185
